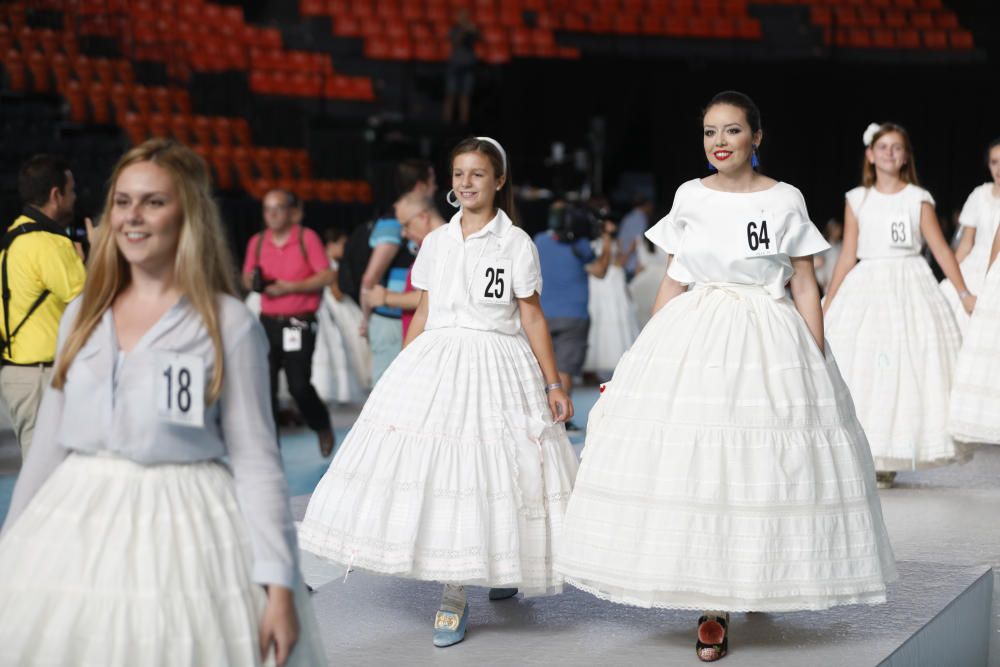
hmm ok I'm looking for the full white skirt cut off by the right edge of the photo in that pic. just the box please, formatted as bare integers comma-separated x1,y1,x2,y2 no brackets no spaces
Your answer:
948,262,1000,445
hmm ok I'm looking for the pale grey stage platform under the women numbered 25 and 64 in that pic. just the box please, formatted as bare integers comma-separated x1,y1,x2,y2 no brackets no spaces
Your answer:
293,440,1000,667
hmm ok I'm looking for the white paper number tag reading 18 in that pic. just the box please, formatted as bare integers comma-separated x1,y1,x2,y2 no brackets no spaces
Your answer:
153,352,205,427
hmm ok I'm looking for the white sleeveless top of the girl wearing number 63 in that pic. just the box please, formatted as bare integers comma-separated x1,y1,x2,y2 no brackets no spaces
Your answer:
846,183,934,259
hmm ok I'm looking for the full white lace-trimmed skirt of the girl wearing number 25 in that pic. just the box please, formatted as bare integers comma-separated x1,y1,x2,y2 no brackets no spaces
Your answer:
299,328,578,595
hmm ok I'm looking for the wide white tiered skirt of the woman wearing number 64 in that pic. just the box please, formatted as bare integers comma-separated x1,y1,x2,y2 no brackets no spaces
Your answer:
556,285,896,611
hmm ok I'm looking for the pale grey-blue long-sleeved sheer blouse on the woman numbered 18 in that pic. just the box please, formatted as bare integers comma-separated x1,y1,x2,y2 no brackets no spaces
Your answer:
5,296,297,587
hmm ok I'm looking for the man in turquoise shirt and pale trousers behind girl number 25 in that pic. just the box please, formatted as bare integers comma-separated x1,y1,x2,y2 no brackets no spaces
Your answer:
361,160,437,383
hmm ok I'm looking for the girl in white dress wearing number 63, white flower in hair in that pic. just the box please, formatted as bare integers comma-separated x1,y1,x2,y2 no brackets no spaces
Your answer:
824,123,976,487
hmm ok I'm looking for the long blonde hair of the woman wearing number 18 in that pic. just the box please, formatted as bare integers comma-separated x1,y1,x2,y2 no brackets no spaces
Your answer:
52,139,236,403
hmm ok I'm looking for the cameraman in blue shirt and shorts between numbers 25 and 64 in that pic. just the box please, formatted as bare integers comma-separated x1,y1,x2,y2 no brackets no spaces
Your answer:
535,201,616,431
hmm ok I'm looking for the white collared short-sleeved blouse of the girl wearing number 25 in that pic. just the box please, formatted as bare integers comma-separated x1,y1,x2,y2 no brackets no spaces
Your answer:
410,210,542,335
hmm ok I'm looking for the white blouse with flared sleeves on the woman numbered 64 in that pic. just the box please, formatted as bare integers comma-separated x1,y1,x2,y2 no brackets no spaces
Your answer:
646,179,830,299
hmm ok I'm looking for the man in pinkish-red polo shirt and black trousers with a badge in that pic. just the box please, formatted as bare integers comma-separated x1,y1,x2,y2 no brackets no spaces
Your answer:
243,190,334,456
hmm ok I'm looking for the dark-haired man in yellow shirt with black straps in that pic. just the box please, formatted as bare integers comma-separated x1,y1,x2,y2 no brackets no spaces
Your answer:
0,155,85,458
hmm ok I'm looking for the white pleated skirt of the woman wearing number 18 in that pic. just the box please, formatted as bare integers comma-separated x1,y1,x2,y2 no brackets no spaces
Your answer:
0,454,327,667
